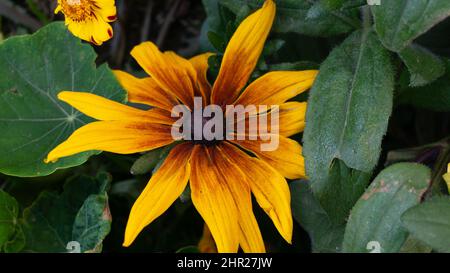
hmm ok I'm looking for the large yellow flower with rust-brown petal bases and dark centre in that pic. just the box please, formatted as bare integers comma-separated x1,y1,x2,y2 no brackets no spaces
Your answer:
46,0,317,252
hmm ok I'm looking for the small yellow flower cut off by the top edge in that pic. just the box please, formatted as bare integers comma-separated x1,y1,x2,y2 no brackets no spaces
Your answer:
55,0,117,45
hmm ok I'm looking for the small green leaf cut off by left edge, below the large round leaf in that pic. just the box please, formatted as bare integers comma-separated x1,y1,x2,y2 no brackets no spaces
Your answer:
0,190,19,251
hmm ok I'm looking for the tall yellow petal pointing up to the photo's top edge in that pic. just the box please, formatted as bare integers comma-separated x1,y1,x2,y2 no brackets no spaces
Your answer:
211,0,276,106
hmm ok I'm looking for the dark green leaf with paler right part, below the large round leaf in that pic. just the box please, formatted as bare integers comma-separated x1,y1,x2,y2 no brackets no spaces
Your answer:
22,174,111,253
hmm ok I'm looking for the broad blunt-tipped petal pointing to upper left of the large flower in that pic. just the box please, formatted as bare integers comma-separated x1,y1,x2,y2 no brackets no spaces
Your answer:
131,42,197,109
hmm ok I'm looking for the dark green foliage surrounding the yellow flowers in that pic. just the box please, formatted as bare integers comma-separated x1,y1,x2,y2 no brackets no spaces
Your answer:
0,0,450,253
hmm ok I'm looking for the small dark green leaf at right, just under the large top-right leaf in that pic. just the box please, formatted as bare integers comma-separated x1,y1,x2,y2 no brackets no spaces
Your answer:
399,44,445,87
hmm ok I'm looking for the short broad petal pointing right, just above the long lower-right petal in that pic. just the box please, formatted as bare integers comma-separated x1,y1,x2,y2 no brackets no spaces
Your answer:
231,135,306,179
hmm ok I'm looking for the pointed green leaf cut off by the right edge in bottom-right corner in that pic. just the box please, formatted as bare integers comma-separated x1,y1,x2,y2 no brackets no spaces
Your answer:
401,197,450,253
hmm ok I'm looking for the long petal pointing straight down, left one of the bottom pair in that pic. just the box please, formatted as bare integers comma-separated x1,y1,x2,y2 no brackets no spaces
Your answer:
190,145,240,253
